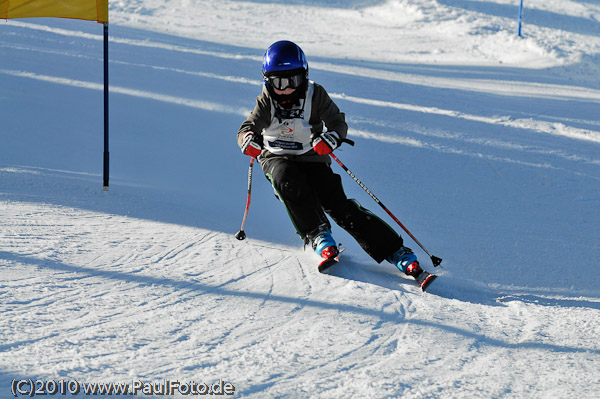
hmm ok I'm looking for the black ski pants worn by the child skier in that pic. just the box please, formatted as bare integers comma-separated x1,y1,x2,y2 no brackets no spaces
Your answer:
261,158,403,263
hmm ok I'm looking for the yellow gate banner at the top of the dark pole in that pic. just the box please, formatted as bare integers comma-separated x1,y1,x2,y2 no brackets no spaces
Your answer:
0,0,108,23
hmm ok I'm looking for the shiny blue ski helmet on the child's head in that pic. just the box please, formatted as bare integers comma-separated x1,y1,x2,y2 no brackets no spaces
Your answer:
262,40,308,84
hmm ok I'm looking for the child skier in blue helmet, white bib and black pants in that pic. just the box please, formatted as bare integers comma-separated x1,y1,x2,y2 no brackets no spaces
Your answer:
237,41,435,290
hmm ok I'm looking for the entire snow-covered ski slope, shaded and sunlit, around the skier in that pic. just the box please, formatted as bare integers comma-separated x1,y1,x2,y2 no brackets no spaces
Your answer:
0,0,600,398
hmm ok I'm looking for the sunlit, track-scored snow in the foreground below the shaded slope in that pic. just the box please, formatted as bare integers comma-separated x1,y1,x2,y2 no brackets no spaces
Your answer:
0,180,600,398
